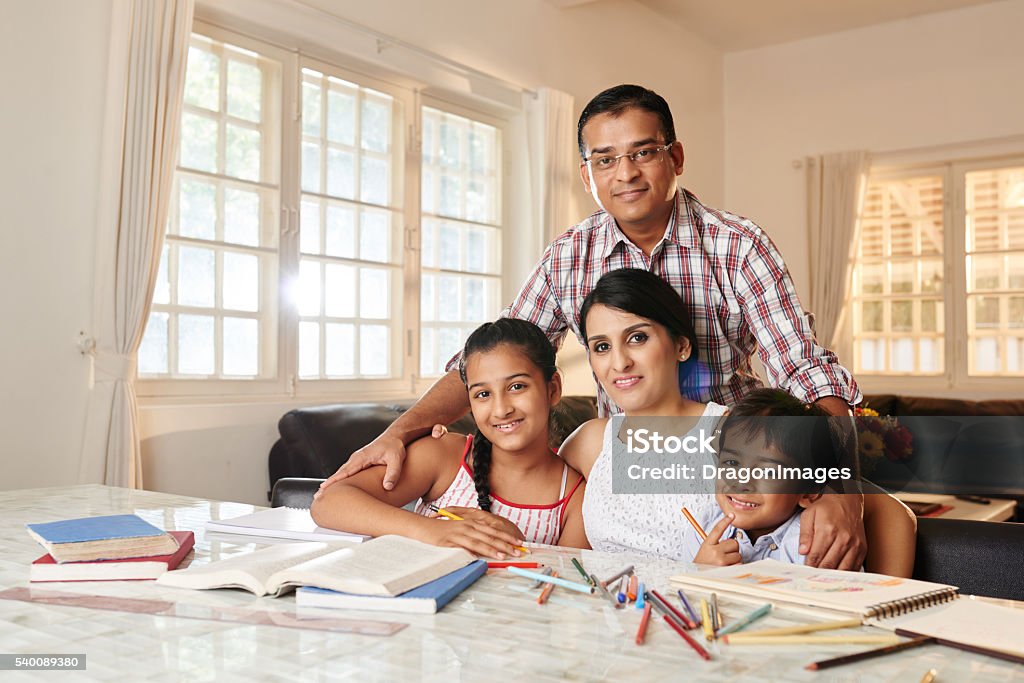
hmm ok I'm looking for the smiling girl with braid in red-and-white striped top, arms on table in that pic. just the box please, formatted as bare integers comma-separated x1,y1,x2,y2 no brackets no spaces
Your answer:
311,318,588,557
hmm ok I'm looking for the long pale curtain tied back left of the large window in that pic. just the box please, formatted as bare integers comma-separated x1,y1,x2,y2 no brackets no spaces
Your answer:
79,0,194,488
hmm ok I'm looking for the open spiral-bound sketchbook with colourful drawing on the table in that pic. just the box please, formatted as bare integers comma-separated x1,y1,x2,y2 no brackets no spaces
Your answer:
671,560,1024,663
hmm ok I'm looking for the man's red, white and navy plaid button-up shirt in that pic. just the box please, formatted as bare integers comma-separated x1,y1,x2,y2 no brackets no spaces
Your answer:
447,189,860,415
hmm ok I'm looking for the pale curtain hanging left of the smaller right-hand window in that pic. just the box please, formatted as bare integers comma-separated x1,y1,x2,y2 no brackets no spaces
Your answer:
805,152,870,348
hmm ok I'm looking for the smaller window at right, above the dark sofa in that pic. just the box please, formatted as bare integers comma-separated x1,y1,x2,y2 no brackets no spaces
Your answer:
852,162,1024,384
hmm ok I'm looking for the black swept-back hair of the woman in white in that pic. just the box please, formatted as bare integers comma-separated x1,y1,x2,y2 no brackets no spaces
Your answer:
580,268,697,380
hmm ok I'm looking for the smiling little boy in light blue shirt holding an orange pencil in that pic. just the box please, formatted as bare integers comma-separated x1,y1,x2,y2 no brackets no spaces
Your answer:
684,389,914,577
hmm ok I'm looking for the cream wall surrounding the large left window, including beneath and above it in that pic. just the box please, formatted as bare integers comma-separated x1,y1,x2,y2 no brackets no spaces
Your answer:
0,0,724,503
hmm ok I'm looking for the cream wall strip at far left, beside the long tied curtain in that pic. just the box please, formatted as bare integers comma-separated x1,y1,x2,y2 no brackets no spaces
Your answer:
0,0,111,488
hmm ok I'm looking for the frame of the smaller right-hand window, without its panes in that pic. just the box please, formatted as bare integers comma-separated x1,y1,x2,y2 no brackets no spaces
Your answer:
845,154,1024,397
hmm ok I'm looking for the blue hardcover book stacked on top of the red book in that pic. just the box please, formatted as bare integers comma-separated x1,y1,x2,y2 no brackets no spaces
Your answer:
26,515,178,562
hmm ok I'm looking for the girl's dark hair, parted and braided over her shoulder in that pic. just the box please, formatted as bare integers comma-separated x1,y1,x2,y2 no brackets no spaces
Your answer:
459,317,558,512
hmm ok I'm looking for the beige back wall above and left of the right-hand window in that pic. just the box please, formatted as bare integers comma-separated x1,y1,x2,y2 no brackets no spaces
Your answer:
725,0,1024,397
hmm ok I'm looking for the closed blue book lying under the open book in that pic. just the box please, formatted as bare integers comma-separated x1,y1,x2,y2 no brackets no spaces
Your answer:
295,560,487,614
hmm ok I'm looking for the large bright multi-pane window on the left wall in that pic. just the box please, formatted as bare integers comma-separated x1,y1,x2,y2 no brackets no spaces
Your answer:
138,22,504,397
